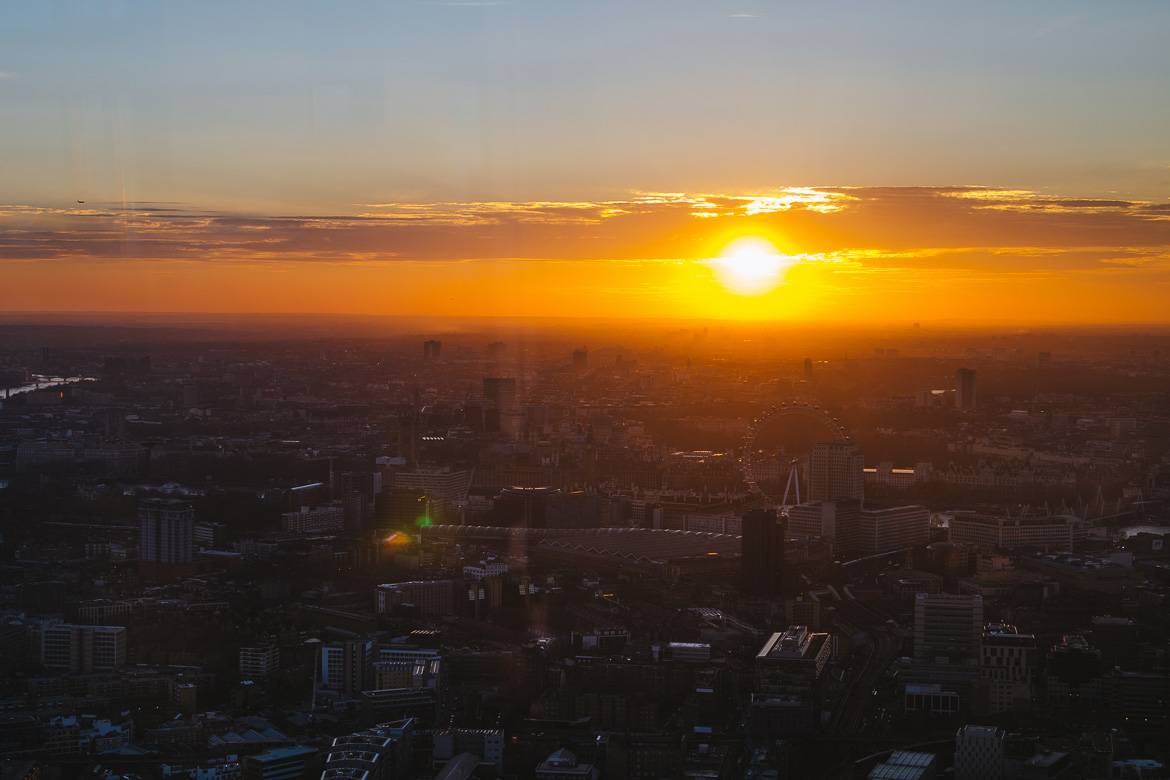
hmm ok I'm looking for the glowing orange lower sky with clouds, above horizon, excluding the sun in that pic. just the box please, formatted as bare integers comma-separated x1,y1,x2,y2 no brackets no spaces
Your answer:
0,187,1170,324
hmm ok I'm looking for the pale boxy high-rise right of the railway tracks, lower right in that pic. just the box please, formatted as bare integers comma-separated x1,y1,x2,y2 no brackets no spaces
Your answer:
914,593,983,665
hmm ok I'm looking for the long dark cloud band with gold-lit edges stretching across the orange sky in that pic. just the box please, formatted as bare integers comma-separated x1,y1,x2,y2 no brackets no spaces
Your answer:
0,186,1170,272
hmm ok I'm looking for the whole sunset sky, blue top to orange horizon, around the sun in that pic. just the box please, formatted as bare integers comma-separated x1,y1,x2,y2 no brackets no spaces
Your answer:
0,0,1170,324
